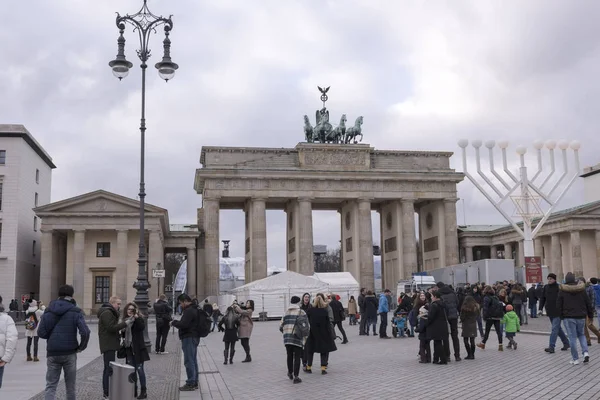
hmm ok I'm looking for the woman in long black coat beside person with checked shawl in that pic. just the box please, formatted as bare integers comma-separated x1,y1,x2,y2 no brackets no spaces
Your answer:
305,295,337,375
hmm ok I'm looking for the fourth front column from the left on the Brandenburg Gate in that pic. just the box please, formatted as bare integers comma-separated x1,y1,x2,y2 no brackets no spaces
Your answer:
358,199,375,290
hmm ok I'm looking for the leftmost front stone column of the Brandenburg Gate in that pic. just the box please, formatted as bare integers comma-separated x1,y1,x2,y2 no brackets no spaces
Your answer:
202,198,221,296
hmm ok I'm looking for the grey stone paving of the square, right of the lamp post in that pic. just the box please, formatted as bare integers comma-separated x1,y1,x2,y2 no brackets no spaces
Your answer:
196,318,600,400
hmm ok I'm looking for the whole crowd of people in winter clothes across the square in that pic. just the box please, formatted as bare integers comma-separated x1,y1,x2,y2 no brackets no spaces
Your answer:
0,273,600,394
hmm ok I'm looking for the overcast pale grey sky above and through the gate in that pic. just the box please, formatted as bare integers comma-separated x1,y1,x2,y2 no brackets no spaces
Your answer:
0,0,600,266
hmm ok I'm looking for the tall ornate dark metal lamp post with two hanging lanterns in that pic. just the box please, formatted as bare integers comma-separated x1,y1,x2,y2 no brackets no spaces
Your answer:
108,0,178,348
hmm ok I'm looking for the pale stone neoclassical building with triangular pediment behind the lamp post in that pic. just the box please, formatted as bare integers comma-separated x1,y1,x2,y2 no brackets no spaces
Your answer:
34,190,200,314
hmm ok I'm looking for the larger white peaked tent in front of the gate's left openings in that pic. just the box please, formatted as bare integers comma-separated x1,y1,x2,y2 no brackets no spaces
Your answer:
229,271,329,318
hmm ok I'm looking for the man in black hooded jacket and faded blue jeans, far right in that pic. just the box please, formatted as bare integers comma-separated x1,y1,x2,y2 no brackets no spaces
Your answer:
556,272,594,365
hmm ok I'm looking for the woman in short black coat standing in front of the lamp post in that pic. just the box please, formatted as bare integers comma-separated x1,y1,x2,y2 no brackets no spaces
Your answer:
122,303,150,399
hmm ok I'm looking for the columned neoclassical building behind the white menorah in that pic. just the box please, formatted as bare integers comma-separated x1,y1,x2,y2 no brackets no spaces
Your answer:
458,200,600,279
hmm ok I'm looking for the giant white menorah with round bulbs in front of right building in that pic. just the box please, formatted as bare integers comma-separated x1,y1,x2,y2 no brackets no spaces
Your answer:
458,139,581,257
